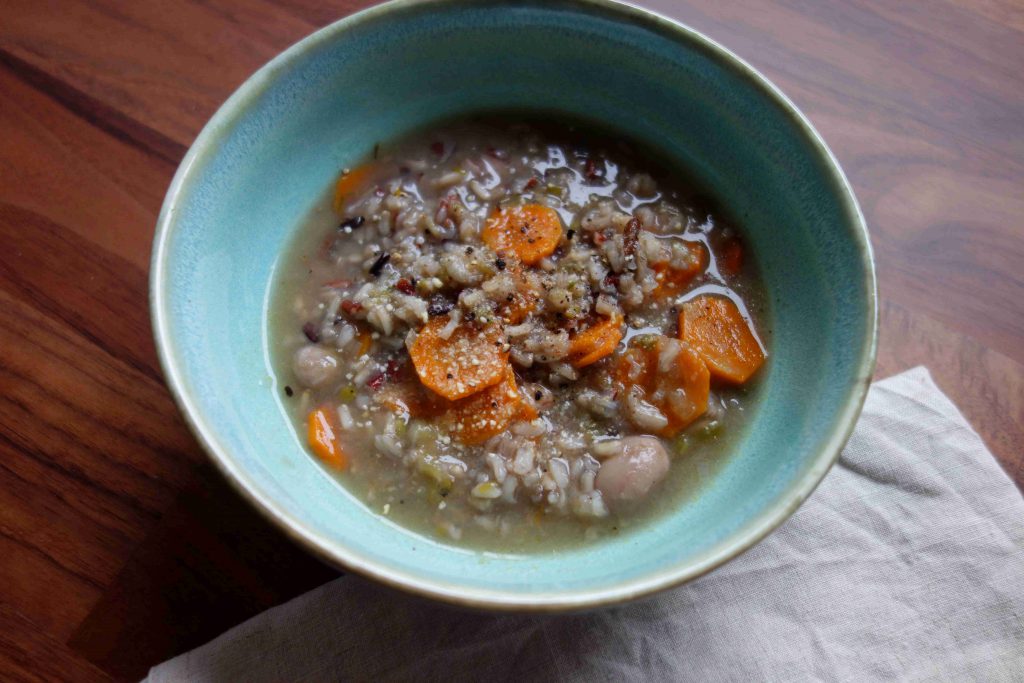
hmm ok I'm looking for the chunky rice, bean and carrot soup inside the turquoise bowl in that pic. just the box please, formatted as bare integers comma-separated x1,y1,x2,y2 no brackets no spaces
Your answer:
269,118,768,551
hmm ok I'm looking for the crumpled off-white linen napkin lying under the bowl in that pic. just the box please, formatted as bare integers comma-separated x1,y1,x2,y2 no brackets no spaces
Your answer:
147,368,1024,683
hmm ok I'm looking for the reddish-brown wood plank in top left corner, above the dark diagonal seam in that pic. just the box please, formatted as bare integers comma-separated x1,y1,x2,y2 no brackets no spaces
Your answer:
0,0,315,146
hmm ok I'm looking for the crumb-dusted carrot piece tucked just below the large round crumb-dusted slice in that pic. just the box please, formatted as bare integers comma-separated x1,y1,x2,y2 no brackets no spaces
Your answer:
443,366,537,445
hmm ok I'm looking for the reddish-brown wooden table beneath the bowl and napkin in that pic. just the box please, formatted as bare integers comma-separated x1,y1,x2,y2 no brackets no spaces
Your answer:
0,0,1024,680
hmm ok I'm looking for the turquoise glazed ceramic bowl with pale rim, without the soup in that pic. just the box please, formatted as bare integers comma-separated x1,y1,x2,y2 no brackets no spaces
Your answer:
152,0,876,610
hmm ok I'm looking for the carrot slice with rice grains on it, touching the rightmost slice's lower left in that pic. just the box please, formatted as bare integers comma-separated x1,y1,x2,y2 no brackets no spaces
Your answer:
612,335,711,437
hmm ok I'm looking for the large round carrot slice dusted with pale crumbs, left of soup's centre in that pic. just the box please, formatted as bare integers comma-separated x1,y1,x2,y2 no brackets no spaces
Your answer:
409,315,509,400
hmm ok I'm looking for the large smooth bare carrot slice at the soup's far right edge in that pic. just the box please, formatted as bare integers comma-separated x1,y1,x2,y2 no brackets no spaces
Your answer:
679,295,765,384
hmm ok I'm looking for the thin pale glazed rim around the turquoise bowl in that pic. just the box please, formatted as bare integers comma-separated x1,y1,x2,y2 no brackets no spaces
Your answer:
150,0,879,612
